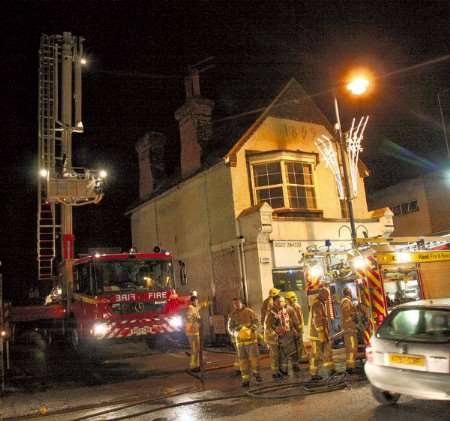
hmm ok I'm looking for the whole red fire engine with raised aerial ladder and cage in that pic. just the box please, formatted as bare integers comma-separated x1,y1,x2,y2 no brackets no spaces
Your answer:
0,32,188,350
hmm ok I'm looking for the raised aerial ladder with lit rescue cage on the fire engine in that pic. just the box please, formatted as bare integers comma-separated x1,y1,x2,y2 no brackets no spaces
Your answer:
37,32,106,294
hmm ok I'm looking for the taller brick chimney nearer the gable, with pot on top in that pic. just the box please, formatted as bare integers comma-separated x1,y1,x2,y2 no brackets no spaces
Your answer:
175,69,214,178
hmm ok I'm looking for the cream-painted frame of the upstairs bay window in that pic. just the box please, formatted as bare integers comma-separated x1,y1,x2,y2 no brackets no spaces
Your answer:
248,151,318,211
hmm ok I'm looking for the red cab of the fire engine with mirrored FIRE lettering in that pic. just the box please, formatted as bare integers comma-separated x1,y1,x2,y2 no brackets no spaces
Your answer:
52,248,189,349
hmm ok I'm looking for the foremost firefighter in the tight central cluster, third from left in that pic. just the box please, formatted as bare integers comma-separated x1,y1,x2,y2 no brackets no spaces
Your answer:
264,295,300,380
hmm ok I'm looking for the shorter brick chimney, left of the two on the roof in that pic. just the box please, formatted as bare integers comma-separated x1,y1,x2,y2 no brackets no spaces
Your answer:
136,132,166,199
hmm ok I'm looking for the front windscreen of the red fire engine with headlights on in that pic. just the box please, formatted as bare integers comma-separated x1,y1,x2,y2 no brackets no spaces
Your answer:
95,259,174,293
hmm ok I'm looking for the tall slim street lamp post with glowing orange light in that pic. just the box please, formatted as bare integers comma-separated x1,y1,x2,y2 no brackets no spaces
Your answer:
334,77,370,249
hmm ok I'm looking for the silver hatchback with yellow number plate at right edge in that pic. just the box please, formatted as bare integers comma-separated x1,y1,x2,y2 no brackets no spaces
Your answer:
364,298,450,405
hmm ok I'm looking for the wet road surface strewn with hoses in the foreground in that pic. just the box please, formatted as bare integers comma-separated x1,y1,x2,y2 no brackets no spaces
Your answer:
0,344,450,421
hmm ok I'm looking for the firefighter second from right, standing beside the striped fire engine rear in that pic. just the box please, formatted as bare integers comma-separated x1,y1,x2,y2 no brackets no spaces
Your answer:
308,288,334,380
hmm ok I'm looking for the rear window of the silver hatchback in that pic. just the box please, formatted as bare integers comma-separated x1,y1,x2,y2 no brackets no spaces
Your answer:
377,307,450,343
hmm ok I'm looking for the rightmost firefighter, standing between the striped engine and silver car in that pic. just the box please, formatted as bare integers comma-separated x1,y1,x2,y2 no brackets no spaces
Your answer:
341,287,358,374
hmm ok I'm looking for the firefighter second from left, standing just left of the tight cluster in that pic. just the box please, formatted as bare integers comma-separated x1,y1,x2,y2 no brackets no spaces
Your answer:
228,298,262,387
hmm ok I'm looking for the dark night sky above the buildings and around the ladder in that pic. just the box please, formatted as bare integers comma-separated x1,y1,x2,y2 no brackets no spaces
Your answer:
0,0,450,295
